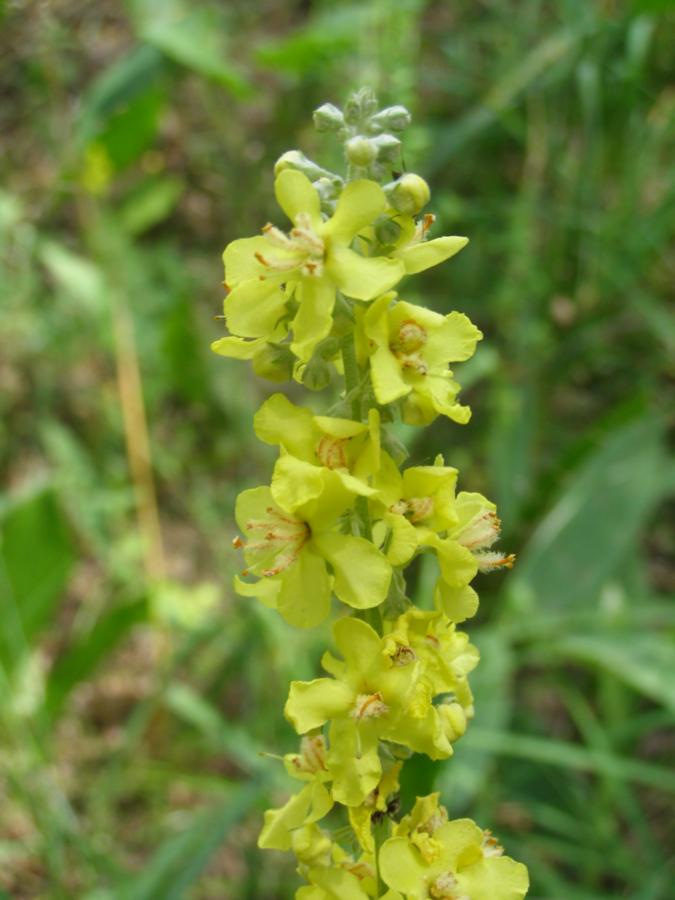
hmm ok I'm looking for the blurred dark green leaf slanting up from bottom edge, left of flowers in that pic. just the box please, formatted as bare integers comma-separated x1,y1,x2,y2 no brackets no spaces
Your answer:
120,781,262,900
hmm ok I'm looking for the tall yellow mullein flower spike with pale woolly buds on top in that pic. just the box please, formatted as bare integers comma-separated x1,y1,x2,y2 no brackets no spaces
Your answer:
213,90,528,900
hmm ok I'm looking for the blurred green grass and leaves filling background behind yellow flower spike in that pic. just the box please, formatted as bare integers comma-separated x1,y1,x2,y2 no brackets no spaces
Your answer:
0,0,675,900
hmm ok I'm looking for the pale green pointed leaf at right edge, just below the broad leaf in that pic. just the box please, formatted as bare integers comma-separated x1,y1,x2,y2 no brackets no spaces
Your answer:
546,629,675,712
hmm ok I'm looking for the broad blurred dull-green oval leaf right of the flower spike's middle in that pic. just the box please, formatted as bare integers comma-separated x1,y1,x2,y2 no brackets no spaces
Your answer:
507,415,664,614
